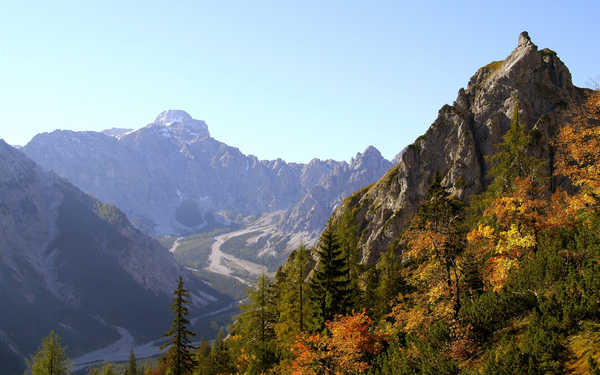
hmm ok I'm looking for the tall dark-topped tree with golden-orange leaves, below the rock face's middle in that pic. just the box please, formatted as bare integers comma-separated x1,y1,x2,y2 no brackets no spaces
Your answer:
392,173,465,331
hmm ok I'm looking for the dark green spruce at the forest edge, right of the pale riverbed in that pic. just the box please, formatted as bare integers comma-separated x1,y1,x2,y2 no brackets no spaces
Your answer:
310,226,349,330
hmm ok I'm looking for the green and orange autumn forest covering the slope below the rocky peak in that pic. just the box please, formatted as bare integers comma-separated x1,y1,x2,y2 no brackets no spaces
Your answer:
138,92,600,375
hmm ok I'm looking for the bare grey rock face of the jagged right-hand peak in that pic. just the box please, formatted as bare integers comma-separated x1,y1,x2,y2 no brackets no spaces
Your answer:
326,32,586,262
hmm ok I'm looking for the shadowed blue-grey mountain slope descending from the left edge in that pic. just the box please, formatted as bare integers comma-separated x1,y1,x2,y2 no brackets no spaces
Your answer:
0,140,229,373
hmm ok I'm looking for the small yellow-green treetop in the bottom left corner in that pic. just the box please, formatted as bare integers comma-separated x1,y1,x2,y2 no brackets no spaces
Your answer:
27,331,71,375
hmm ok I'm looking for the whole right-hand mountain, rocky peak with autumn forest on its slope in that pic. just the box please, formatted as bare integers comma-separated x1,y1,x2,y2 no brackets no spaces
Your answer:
198,33,600,375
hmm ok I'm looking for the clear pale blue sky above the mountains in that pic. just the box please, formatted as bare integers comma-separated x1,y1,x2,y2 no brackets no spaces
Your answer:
0,0,600,162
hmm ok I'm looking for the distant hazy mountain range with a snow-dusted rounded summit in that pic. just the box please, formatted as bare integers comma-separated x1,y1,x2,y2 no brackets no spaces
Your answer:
23,110,392,247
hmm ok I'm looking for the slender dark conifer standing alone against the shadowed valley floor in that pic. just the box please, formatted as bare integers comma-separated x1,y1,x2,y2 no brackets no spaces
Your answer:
161,276,196,375
